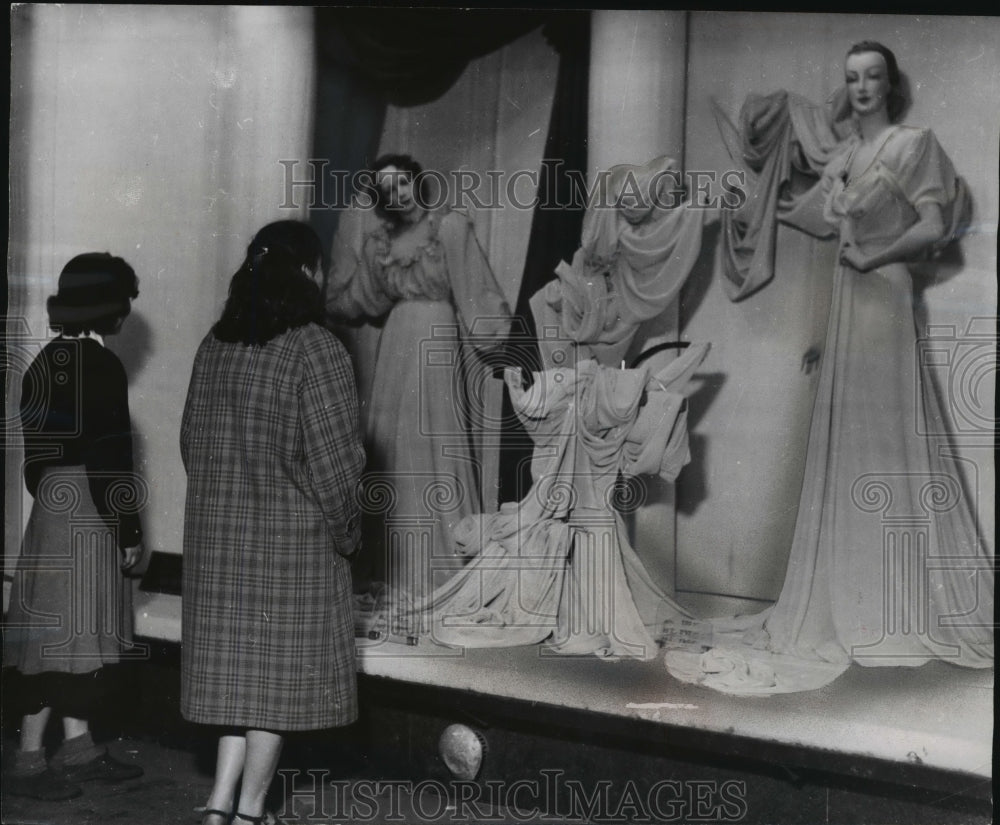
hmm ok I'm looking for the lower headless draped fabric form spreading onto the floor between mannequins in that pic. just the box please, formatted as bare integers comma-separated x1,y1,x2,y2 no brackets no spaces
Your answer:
390,344,709,659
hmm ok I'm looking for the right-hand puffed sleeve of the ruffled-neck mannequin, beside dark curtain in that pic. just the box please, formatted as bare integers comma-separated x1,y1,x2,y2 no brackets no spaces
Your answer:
439,211,511,351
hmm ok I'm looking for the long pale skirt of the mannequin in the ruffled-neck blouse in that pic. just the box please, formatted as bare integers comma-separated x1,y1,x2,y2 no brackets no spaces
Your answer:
362,300,481,609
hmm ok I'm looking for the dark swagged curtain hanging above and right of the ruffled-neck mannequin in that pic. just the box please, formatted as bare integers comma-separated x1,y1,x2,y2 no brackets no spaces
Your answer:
310,8,590,501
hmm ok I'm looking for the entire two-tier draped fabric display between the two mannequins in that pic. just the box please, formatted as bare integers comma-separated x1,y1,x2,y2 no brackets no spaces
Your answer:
356,158,708,659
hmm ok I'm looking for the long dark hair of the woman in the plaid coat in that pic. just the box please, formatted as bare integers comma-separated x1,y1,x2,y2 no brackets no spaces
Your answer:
212,220,323,345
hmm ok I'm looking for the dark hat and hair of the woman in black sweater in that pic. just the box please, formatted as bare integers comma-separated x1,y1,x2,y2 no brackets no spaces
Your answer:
48,252,139,326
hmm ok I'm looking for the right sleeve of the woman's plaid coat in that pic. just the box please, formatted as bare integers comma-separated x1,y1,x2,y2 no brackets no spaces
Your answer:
299,327,365,556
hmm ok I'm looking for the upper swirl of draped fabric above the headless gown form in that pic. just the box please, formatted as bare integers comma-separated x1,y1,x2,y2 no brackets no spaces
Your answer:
531,157,708,368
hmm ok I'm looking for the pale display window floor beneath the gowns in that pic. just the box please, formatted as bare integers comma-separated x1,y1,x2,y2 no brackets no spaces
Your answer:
136,593,993,788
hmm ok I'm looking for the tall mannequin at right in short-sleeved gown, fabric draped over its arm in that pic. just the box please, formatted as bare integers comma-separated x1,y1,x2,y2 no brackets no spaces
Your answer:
667,41,993,694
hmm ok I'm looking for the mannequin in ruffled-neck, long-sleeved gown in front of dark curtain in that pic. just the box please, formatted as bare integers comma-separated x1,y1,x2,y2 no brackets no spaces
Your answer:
326,155,510,620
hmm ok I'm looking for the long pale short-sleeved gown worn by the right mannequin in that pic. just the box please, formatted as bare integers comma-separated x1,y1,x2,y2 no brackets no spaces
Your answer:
666,93,993,694
